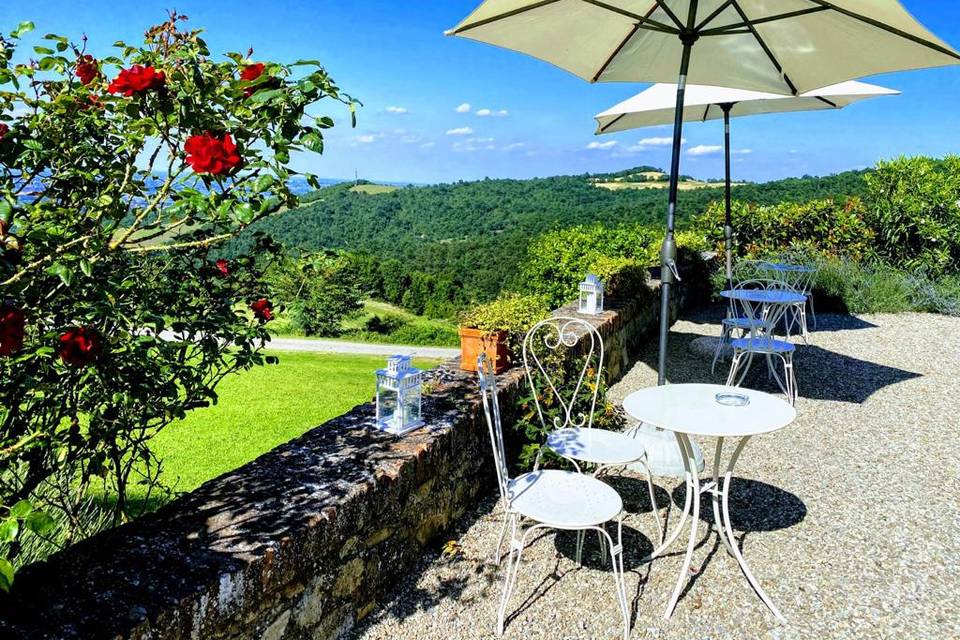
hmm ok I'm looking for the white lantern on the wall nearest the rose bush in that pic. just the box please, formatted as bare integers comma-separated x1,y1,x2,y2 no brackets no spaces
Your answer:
377,356,423,435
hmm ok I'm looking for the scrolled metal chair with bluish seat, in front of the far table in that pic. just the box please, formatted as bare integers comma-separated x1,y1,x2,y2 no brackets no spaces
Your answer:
727,280,797,404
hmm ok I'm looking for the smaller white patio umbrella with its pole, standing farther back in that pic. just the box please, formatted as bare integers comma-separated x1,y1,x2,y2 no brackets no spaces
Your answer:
594,80,900,283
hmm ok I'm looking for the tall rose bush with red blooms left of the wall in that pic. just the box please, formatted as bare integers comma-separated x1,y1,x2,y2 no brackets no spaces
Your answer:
0,14,355,589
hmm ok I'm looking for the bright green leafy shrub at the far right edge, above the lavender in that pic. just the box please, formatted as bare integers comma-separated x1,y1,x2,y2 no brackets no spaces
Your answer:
867,156,960,275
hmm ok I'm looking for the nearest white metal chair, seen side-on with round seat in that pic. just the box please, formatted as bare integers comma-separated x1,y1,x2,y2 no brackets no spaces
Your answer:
477,354,630,640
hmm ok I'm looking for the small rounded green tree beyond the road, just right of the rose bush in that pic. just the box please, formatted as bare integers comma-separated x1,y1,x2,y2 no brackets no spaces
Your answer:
270,254,363,336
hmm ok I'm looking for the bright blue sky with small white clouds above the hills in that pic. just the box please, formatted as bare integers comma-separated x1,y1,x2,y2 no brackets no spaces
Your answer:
0,0,960,182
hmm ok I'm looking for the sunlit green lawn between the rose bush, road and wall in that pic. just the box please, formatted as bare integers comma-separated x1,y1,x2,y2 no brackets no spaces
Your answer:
145,352,436,498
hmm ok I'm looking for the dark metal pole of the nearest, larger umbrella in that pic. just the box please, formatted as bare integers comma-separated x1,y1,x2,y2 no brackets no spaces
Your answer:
657,36,696,385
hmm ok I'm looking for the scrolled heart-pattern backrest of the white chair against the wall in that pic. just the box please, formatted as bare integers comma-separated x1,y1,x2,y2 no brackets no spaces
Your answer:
523,316,603,430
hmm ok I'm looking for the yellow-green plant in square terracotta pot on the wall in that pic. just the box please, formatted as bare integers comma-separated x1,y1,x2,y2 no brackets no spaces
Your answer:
459,293,550,373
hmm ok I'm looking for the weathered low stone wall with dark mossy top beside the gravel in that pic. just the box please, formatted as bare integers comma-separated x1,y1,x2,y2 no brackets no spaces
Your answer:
0,282,681,640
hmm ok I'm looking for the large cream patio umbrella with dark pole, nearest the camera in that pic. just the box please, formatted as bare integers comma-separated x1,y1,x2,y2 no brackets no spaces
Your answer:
447,0,960,384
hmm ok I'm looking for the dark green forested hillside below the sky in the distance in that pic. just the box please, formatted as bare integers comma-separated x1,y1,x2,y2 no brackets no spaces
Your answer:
231,167,864,300
